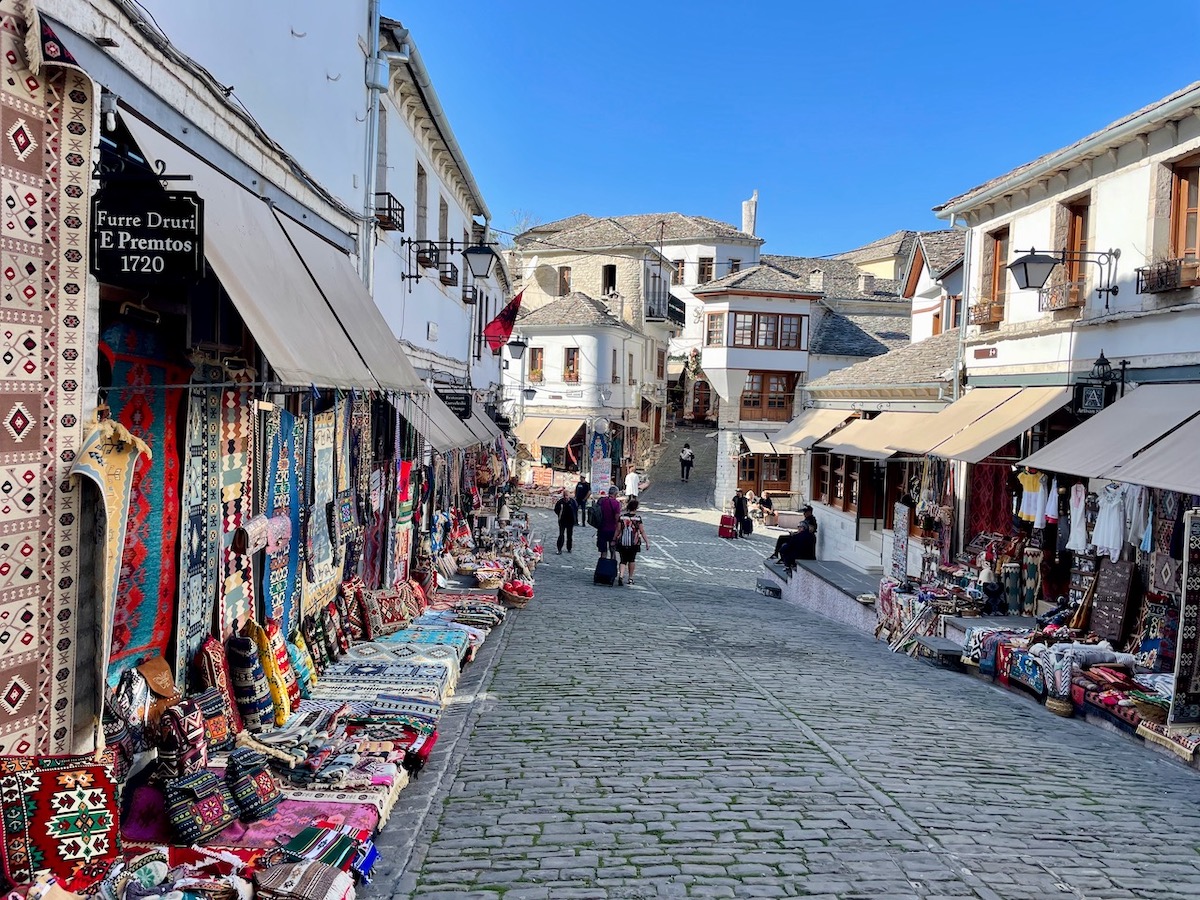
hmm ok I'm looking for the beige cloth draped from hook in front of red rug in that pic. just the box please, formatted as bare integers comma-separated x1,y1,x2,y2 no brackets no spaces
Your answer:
71,421,151,696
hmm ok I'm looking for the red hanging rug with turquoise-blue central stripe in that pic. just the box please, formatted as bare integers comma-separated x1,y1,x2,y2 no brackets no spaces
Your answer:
100,322,187,685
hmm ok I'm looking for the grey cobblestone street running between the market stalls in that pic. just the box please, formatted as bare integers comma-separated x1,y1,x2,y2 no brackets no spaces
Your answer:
361,434,1200,900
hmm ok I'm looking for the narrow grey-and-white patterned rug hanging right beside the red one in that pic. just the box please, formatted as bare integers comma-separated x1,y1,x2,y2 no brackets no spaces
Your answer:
175,361,226,686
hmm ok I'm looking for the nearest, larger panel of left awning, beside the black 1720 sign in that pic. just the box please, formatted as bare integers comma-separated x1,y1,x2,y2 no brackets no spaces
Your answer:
121,113,379,390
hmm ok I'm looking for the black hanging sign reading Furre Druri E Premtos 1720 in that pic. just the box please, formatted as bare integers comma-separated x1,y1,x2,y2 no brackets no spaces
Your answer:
91,184,204,286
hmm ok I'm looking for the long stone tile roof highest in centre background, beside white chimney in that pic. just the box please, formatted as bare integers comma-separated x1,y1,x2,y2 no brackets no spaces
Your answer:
514,212,763,251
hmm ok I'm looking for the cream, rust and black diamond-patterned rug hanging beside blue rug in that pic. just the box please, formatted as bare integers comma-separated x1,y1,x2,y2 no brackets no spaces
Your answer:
220,368,254,637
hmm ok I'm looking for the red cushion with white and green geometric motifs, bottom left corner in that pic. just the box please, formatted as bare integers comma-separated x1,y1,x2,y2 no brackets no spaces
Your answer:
0,754,120,890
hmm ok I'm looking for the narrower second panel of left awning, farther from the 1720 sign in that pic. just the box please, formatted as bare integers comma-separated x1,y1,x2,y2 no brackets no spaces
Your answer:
275,210,426,391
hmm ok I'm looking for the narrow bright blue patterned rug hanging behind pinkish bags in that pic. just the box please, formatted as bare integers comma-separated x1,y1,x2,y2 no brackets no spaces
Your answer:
263,410,307,634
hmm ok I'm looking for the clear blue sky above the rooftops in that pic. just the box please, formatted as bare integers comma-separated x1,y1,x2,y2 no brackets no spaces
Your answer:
383,0,1200,256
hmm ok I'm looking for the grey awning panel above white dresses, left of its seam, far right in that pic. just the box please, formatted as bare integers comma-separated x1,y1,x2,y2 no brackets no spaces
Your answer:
1021,384,1200,484
